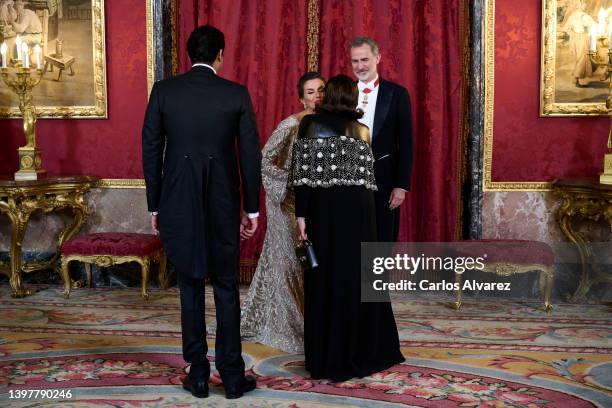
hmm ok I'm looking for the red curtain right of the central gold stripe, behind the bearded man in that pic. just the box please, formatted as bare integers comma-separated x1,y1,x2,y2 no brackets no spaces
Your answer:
320,0,462,241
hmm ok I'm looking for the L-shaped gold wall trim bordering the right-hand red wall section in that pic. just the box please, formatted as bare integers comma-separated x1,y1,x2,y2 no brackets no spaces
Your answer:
483,0,551,191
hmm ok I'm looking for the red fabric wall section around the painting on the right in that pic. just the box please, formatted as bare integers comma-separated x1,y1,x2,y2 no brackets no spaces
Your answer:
492,0,609,182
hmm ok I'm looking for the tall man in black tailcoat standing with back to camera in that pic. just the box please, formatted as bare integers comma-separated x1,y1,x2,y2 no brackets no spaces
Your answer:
142,25,261,399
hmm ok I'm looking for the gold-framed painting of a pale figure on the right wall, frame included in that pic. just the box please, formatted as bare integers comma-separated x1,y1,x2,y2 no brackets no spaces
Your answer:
540,0,612,116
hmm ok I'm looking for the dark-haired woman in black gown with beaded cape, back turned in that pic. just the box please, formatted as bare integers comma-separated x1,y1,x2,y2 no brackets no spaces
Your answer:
290,75,404,381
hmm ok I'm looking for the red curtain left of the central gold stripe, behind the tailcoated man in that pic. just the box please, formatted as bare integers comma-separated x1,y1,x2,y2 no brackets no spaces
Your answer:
178,0,307,259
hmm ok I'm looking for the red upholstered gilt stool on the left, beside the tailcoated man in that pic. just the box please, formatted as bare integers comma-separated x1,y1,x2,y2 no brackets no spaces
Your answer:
60,232,168,300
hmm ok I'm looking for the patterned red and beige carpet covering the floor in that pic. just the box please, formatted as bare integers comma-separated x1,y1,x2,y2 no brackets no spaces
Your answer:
0,285,612,408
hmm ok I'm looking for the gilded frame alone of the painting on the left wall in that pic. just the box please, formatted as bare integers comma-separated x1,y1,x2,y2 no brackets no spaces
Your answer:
0,0,108,119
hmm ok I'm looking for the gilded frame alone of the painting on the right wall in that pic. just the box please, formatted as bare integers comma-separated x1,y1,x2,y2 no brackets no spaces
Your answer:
540,0,607,116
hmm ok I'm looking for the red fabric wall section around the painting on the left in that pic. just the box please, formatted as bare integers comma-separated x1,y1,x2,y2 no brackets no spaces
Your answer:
0,0,147,178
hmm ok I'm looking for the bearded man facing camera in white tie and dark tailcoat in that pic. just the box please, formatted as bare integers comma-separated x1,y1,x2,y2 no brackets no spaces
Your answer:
350,37,412,242
